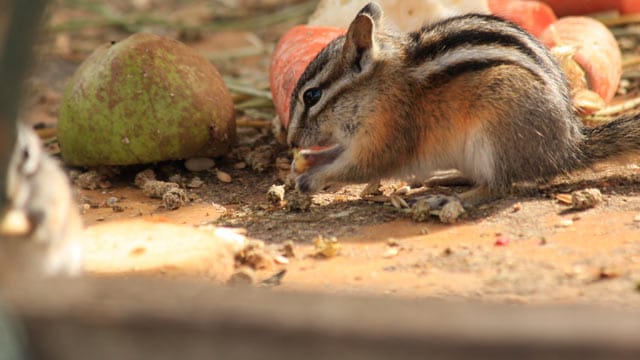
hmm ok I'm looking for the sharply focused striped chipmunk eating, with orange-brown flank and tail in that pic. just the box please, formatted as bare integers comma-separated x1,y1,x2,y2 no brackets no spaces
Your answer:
287,3,640,205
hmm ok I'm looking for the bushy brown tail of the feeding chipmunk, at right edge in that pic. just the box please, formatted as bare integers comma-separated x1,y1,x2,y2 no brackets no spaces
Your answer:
580,113,640,166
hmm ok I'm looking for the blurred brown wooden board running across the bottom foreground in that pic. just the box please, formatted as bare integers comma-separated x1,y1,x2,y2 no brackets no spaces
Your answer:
3,278,640,360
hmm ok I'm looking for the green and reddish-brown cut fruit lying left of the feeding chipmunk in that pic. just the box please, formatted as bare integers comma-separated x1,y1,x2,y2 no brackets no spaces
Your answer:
58,33,235,166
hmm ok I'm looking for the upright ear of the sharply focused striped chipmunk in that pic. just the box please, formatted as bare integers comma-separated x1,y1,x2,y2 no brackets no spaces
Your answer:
342,3,382,72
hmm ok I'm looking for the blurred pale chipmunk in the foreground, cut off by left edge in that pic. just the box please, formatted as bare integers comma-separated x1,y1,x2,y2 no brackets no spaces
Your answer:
0,124,82,274
